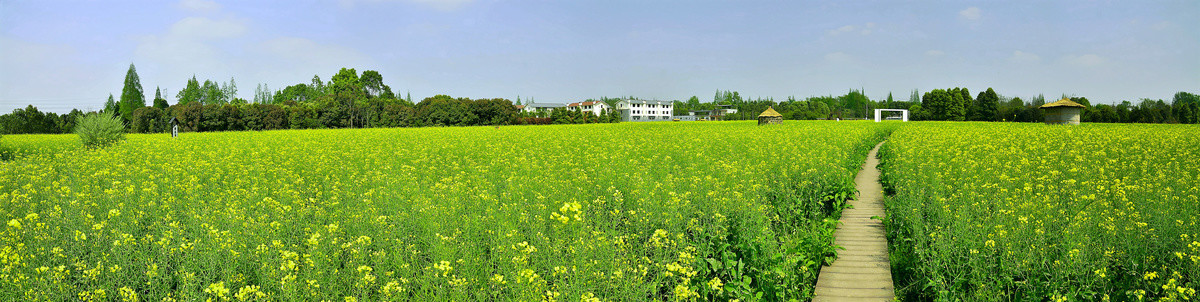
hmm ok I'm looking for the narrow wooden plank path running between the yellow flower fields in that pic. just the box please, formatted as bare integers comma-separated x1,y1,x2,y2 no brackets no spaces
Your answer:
812,143,895,302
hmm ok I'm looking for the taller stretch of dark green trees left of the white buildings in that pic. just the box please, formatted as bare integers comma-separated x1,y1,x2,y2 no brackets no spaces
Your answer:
0,65,619,134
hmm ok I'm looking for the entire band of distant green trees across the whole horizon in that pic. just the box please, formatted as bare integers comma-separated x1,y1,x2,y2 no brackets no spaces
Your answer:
0,65,1200,134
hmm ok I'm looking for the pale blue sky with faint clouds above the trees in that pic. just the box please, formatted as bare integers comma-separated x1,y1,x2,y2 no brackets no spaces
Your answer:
0,0,1200,113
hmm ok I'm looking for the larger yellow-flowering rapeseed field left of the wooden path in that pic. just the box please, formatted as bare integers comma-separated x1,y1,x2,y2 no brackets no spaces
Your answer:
0,121,892,301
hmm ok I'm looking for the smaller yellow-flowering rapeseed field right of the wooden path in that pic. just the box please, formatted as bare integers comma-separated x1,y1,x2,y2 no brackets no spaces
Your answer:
881,122,1200,301
